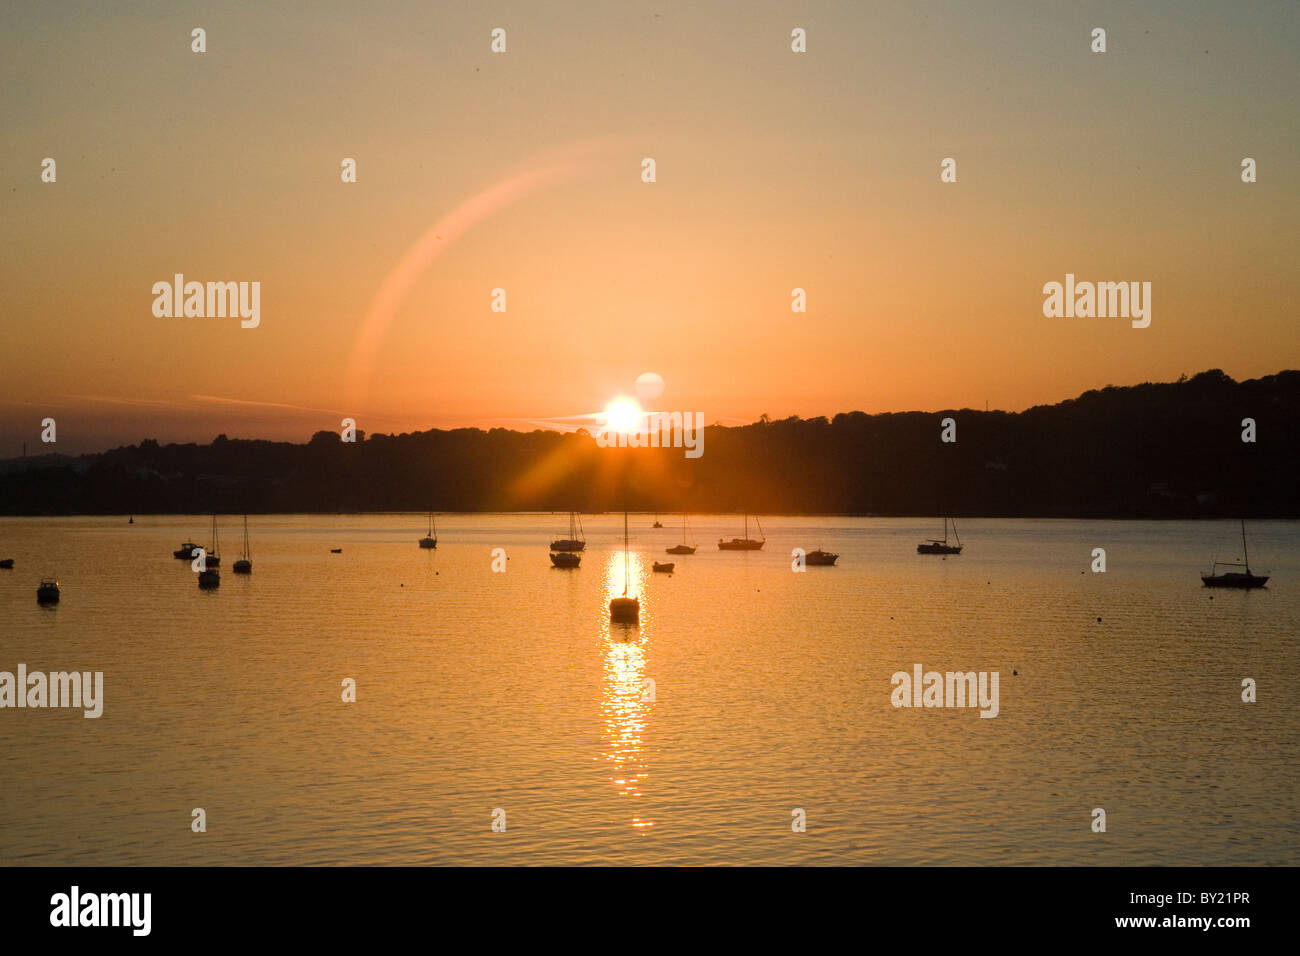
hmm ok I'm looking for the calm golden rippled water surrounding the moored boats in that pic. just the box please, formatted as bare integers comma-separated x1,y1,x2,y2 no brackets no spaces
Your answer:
0,515,1300,865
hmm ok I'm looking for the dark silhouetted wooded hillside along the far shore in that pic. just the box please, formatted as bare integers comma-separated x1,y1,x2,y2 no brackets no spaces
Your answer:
0,369,1300,518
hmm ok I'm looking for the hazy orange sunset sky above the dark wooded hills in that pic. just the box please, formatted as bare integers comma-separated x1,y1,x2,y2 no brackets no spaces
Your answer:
0,3,1300,457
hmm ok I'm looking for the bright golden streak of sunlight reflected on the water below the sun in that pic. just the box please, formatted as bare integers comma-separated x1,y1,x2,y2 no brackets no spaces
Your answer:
601,551,654,830
